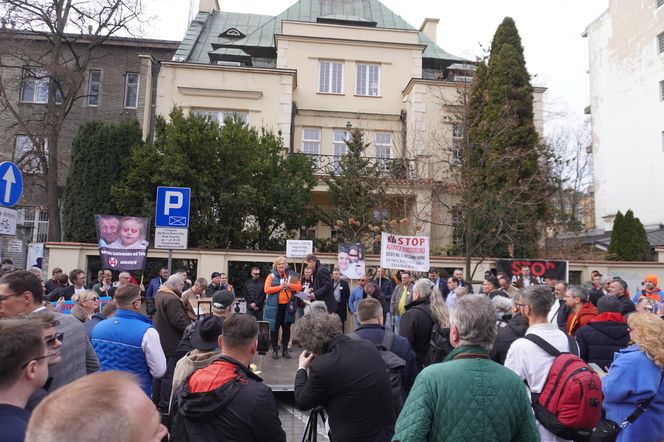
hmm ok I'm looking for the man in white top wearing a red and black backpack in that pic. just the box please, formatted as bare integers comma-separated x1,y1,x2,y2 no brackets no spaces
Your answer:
505,285,602,441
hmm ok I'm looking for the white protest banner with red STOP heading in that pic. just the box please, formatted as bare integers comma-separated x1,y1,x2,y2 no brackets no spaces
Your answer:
380,232,429,272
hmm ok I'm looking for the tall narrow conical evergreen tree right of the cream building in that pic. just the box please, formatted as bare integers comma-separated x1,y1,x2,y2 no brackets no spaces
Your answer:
462,18,551,257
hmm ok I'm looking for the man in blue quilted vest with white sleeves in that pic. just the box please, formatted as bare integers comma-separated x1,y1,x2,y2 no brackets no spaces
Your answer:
92,285,166,396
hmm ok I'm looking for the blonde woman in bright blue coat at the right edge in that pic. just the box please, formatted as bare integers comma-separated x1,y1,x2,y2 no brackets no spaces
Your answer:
602,313,664,442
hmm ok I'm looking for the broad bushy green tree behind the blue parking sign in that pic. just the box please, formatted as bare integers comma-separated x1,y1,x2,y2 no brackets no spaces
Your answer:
113,109,316,250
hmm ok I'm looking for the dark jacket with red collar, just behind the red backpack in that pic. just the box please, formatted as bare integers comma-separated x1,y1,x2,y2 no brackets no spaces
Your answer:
575,313,629,369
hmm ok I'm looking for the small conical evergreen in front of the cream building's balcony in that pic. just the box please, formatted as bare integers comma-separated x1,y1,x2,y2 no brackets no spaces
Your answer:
318,129,387,242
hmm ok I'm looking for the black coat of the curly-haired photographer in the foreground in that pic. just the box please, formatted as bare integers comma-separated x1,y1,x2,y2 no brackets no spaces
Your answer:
295,336,396,442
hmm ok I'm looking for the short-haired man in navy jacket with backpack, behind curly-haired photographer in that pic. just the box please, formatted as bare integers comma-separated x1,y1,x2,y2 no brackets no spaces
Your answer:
351,298,417,401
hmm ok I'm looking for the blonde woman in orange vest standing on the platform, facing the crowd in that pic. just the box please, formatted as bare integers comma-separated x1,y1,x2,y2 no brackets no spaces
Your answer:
263,256,302,359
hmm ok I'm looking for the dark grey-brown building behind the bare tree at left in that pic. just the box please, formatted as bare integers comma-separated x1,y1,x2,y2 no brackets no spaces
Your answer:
0,28,178,242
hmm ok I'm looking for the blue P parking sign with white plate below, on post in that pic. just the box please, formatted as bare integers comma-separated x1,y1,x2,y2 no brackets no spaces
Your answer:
154,186,191,274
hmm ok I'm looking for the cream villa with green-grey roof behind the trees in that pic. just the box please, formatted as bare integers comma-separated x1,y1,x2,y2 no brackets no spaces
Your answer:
146,0,544,247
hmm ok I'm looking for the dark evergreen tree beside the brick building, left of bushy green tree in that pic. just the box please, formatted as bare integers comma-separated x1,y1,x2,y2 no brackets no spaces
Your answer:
63,119,142,242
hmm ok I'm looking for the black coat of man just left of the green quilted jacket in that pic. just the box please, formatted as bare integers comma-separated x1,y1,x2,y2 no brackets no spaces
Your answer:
399,299,435,370
